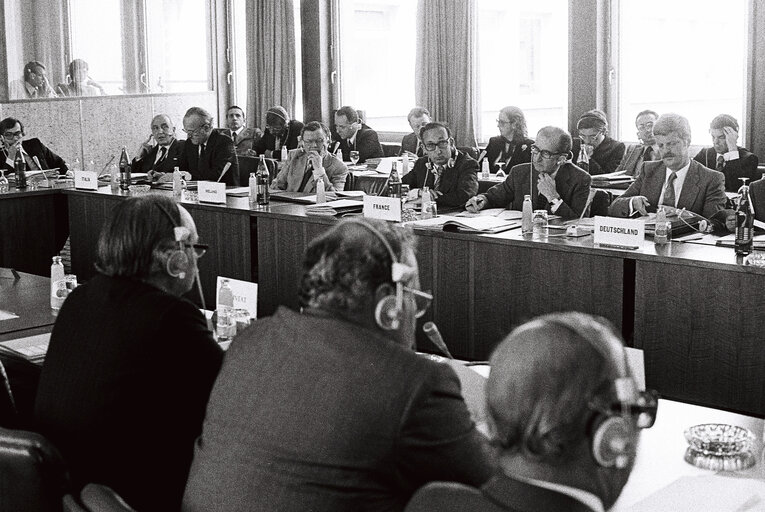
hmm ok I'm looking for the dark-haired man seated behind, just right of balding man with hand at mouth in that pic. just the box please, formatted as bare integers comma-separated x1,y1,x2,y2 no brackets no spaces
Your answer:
572,109,625,175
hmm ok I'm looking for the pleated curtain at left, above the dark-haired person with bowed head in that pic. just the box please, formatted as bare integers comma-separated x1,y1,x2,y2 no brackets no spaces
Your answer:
247,0,295,127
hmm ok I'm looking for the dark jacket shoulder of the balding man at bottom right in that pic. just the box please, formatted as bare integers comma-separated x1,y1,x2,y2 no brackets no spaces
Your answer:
405,473,592,512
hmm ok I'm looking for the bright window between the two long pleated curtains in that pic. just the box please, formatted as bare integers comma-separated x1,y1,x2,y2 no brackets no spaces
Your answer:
337,0,417,132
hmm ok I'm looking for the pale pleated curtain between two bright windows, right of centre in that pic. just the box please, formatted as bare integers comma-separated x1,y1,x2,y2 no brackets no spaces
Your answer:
415,0,478,147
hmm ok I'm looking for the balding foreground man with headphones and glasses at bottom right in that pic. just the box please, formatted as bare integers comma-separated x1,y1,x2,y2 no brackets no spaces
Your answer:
406,313,657,512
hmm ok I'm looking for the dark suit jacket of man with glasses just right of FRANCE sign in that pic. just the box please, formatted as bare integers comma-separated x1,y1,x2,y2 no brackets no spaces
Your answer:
401,150,478,208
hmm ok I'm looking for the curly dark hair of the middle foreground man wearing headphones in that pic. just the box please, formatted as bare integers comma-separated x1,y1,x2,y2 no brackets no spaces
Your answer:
299,218,414,313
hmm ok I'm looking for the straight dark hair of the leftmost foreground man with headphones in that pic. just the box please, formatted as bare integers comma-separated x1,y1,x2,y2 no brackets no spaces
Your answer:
96,194,182,279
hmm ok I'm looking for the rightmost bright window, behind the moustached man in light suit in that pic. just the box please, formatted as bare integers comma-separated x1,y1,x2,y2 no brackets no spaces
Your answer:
615,0,748,145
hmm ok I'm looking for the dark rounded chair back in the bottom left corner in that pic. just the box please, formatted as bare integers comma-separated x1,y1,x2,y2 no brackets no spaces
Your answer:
0,428,70,512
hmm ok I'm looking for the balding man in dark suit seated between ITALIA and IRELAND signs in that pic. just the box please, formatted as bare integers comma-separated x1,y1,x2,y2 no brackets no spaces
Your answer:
132,114,183,181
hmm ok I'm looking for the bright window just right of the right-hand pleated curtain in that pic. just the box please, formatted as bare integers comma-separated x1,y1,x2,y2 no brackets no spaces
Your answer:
476,0,568,142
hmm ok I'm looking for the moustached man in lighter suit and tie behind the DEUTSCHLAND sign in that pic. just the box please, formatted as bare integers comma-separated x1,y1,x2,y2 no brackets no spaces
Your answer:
608,114,727,220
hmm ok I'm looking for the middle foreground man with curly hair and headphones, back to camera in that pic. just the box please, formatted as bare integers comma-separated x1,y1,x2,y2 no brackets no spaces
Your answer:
183,218,493,512
